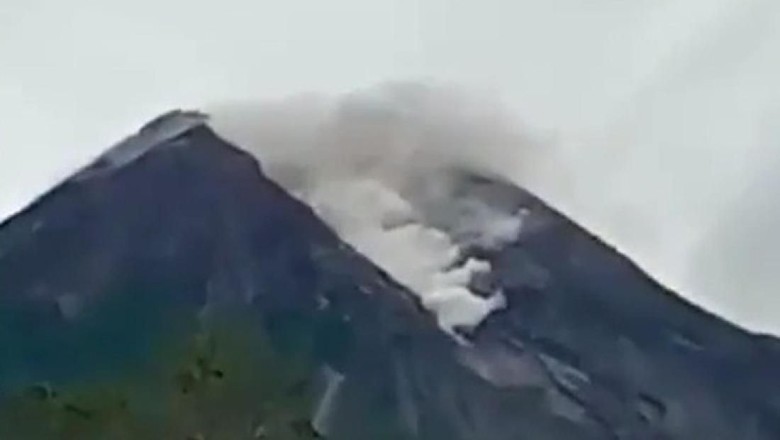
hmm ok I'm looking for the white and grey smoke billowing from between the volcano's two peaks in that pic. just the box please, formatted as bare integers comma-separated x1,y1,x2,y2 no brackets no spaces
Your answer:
211,84,533,330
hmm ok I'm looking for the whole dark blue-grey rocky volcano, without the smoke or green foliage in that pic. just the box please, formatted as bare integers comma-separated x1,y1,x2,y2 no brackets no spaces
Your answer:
0,112,780,440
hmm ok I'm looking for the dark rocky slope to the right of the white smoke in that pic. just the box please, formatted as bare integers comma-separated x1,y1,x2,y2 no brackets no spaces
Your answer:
426,176,780,439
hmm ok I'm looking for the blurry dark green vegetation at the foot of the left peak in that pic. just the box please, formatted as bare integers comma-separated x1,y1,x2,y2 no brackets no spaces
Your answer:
0,312,320,440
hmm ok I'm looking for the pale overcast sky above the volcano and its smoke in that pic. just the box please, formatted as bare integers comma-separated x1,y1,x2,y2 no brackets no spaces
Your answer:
0,0,780,333
